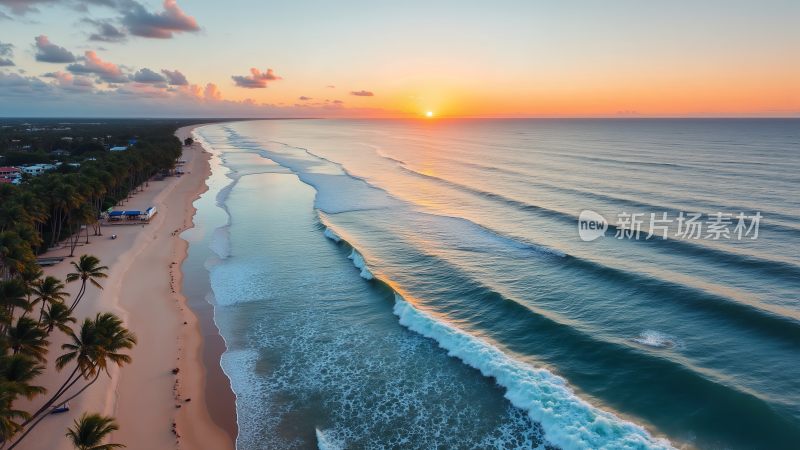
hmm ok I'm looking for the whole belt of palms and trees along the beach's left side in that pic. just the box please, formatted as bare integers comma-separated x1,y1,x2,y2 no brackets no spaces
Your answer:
0,124,191,449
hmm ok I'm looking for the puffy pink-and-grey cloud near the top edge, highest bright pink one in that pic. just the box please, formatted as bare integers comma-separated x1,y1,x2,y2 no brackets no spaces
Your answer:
122,0,200,39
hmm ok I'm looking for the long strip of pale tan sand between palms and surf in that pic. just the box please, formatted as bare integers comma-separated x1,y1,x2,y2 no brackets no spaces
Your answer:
19,126,237,450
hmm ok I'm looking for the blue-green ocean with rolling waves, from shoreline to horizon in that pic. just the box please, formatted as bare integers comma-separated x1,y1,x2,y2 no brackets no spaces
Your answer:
187,119,800,449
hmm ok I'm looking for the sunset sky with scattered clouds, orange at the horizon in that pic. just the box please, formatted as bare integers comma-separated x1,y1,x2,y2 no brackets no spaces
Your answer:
0,0,800,117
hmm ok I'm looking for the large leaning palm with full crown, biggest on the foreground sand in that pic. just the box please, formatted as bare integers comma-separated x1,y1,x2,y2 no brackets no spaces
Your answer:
9,313,136,450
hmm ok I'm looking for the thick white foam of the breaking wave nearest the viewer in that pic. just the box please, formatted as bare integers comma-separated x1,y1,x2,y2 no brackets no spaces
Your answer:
394,295,673,450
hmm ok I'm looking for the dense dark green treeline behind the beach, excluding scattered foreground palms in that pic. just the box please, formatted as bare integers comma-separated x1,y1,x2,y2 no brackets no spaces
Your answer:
0,133,181,279
